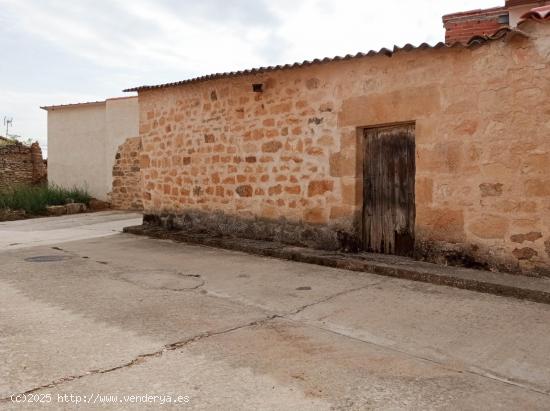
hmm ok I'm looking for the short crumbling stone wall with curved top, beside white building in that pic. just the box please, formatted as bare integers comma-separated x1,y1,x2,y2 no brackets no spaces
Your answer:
111,137,143,210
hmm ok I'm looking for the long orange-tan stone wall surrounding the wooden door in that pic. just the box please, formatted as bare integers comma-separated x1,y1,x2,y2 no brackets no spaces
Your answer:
139,22,550,273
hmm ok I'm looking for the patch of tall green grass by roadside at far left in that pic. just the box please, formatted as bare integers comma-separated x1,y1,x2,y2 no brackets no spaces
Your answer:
0,185,91,214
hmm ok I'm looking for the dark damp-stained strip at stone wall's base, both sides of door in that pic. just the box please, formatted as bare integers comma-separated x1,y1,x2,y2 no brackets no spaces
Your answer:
143,210,550,277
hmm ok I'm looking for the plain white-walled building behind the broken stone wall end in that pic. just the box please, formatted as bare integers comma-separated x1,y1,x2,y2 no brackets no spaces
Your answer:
42,96,139,201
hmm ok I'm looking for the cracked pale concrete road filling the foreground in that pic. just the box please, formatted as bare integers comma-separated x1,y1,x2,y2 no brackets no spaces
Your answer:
0,212,550,410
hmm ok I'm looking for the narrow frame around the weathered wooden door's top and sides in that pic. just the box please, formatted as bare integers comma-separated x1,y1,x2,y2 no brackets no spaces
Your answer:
356,120,418,251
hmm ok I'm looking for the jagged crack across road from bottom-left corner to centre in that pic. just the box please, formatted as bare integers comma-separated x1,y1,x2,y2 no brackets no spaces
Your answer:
0,314,281,404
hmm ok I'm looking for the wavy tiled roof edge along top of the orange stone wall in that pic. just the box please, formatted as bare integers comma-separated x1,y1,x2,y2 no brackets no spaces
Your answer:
124,27,527,92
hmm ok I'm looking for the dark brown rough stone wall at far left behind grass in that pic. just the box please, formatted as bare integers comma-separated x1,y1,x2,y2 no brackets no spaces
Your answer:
0,142,47,190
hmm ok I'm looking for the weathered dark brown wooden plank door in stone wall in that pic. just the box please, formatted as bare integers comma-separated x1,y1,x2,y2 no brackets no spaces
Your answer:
363,124,416,255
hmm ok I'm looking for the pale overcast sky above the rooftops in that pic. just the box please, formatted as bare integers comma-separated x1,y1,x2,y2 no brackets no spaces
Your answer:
0,0,504,156
